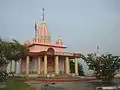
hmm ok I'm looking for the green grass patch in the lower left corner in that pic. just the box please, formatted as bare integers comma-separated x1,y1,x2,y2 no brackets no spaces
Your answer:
0,77,35,90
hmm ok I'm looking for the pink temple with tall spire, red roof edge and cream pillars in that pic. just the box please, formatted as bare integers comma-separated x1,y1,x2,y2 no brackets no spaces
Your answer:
19,9,80,77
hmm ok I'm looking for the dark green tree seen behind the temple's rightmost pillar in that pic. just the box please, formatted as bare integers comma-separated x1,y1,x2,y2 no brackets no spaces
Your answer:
70,61,84,76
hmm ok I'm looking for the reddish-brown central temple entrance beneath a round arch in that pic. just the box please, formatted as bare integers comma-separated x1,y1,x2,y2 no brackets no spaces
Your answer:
47,48,55,73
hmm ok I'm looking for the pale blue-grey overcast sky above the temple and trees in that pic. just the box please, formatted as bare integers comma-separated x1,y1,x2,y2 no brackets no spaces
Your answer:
0,0,120,55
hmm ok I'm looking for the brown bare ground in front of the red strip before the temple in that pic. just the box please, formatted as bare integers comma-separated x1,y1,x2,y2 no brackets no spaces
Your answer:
27,80,120,90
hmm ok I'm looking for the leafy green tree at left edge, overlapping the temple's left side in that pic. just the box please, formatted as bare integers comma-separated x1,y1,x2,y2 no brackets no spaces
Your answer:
0,38,28,81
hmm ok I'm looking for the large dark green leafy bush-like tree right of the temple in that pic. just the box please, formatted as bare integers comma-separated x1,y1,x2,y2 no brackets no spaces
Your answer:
81,54,120,83
